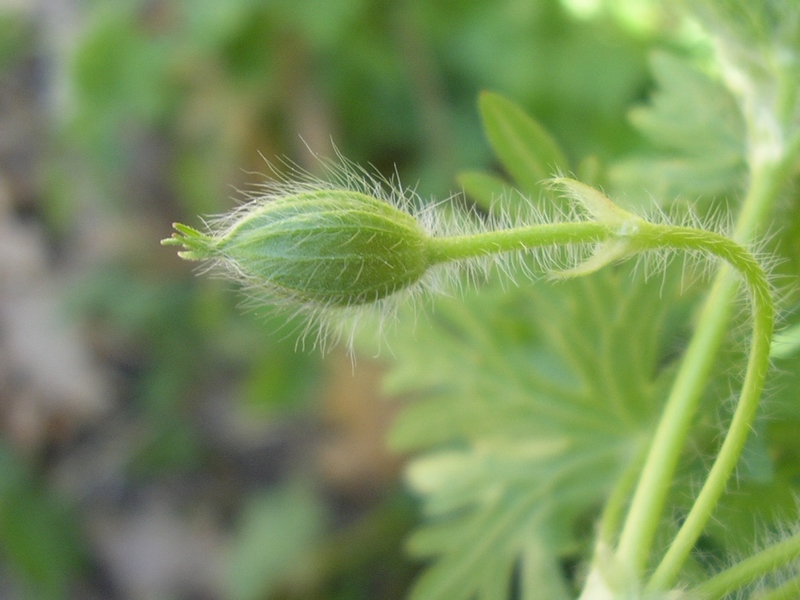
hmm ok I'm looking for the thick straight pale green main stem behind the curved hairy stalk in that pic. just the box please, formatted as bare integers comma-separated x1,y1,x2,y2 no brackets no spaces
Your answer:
608,16,800,572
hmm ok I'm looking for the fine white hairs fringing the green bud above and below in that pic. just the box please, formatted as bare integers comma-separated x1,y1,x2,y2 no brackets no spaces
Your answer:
191,150,491,355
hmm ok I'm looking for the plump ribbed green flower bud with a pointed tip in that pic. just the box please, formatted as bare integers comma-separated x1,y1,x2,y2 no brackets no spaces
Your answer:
162,189,431,307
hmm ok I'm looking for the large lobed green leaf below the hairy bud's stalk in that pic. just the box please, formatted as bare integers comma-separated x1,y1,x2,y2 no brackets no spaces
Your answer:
387,268,692,600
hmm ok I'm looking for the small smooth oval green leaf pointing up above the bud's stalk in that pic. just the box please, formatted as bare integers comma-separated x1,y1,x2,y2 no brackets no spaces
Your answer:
478,92,569,197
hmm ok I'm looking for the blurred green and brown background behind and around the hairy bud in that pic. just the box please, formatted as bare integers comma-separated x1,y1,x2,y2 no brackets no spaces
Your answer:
0,0,674,600
